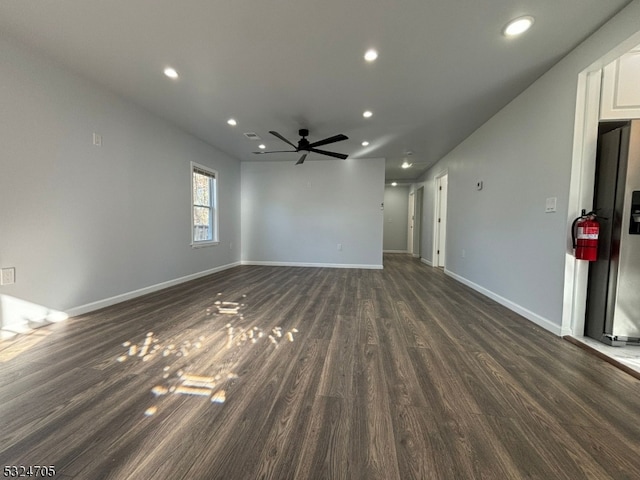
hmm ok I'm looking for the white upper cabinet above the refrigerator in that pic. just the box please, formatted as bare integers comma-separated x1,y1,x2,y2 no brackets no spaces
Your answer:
600,45,640,120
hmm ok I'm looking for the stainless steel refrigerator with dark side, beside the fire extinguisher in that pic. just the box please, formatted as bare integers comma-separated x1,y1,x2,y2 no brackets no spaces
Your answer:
585,120,640,346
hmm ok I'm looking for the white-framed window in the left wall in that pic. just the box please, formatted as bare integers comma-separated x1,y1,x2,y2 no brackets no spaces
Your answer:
191,162,218,247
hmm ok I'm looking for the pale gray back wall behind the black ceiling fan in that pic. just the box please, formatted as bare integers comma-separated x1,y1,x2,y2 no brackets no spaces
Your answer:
242,158,384,268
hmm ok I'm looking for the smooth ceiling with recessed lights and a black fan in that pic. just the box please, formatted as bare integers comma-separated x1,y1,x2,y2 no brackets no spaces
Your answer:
0,0,630,181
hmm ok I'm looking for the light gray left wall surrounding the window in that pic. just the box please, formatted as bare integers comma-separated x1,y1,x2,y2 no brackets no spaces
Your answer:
0,35,240,311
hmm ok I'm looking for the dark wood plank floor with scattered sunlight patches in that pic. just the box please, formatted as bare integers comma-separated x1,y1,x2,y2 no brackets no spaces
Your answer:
0,255,640,480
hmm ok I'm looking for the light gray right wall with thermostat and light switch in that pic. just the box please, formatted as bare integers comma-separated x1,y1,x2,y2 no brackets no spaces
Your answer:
422,1,640,334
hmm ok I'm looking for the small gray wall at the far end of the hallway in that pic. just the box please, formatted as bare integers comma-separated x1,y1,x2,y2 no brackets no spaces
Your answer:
383,186,409,252
